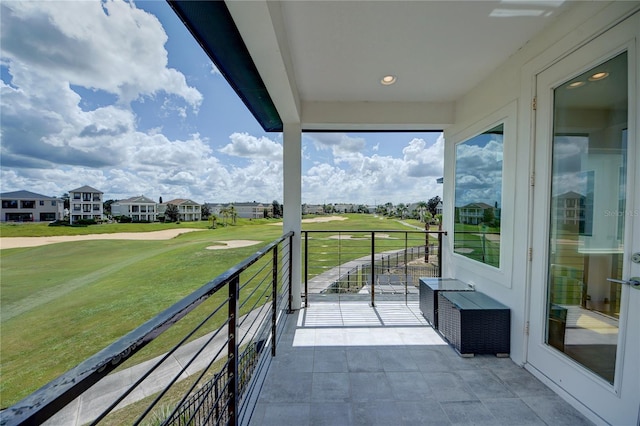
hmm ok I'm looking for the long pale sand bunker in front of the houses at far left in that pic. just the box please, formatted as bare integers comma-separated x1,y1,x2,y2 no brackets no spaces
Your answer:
0,228,204,250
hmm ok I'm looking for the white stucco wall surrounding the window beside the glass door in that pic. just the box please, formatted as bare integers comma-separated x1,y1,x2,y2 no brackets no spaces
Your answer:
443,2,637,364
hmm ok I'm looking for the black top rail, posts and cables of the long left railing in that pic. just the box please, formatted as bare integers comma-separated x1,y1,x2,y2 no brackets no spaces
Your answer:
0,232,294,426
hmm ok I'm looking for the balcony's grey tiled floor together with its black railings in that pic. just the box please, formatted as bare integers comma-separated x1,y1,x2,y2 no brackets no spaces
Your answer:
0,231,589,426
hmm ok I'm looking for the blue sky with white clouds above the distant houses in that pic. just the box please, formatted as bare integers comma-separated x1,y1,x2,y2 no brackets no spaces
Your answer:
0,0,444,204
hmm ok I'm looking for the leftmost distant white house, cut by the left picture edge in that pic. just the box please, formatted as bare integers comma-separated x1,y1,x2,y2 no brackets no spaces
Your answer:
0,191,64,222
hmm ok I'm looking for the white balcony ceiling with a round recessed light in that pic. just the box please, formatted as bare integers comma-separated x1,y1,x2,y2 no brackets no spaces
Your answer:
172,0,573,130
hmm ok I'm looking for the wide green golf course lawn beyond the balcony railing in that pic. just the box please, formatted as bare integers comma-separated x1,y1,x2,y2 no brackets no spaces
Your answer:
0,215,424,408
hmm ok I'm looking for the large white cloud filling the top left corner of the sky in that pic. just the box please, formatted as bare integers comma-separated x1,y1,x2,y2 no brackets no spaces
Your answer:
1,0,202,109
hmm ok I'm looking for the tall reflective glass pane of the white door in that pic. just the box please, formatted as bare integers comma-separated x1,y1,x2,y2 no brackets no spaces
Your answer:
546,53,628,383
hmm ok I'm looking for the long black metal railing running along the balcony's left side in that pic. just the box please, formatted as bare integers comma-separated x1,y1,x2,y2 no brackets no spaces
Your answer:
0,232,293,425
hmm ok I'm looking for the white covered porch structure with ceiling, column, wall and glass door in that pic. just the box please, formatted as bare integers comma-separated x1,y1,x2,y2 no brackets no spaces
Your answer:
169,0,640,425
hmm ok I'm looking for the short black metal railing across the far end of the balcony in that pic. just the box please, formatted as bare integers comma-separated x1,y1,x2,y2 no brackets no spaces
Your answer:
302,230,446,306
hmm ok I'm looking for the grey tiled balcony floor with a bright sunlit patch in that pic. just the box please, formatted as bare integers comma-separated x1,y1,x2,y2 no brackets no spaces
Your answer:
250,297,592,426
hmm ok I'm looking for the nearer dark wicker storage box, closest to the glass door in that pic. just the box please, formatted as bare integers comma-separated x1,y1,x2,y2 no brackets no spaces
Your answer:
438,291,511,356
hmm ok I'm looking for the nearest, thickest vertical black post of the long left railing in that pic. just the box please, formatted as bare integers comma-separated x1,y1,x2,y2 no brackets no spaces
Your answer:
227,275,240,426
